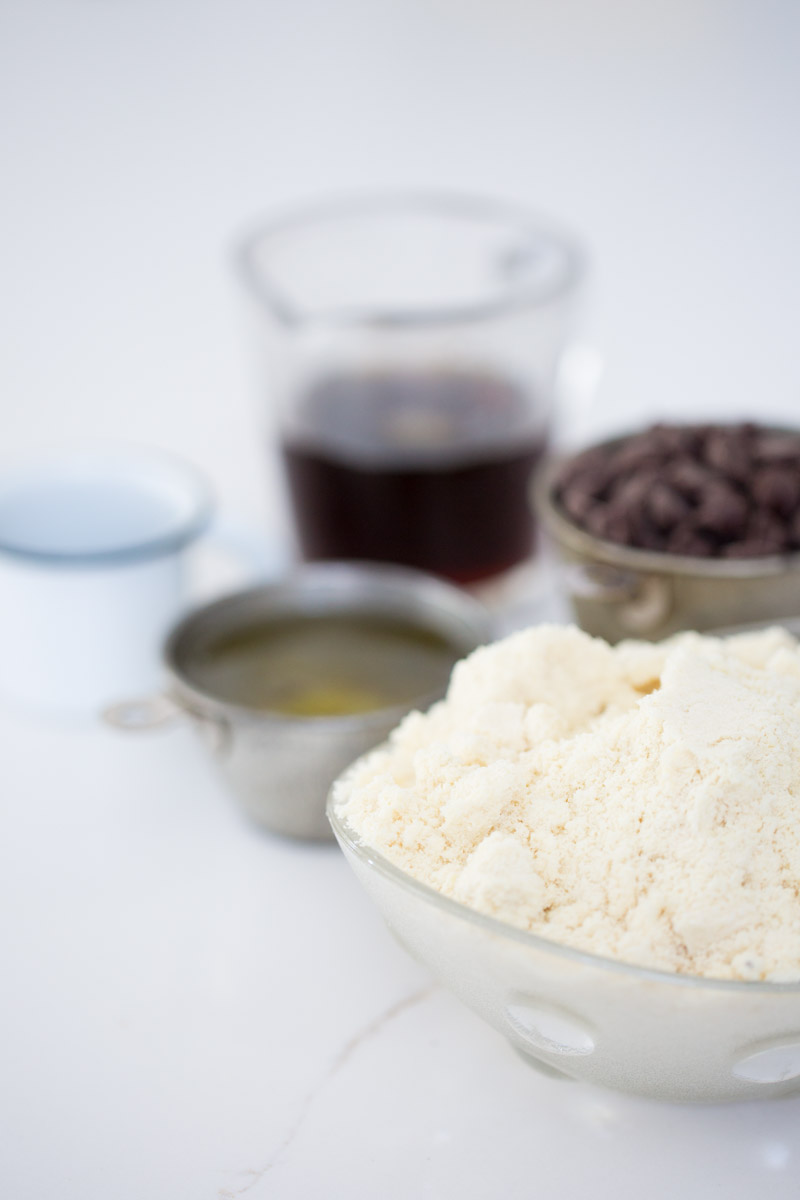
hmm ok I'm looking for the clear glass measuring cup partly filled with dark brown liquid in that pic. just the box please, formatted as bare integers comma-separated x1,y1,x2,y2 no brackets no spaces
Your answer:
240,193,583,584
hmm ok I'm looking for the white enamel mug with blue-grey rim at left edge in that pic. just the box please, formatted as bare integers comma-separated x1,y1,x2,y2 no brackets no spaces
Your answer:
0,448,213,714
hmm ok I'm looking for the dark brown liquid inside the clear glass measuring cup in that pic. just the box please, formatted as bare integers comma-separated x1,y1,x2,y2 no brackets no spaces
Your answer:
283,371,543,583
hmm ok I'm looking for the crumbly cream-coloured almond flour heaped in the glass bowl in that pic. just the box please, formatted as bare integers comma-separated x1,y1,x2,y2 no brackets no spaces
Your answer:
335,625,800,980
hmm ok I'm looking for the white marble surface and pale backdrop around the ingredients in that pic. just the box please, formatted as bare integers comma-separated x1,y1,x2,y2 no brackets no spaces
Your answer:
0,0,800,1200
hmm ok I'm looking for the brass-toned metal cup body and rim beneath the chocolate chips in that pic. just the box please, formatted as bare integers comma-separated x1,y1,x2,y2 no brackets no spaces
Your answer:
534,438,800,643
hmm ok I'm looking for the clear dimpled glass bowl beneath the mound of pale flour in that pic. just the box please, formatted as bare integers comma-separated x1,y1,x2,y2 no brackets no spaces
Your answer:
327,786,800,1103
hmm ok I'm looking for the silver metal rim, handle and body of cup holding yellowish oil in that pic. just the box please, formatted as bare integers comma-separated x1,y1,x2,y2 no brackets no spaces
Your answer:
104,563,491,840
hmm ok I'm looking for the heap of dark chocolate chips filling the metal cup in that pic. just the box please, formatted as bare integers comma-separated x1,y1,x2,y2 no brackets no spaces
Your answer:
554,424,800,558
